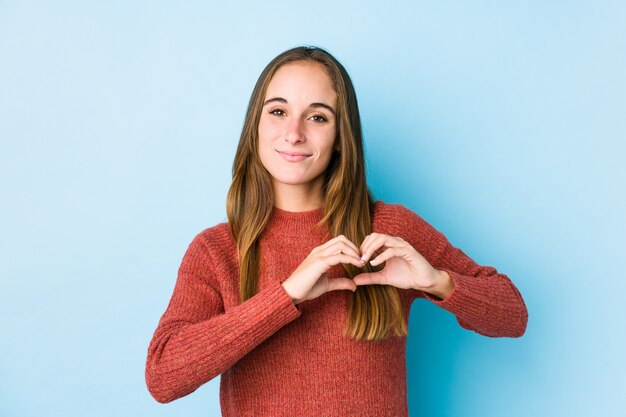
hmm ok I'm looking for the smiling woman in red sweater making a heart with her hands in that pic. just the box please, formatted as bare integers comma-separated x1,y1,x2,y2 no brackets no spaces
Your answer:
146,47,528,417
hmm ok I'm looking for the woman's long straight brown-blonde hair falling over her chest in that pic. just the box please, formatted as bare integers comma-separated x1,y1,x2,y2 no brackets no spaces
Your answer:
226,46,408,341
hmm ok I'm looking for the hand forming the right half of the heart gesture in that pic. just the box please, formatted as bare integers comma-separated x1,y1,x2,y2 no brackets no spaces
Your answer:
352,233,450,292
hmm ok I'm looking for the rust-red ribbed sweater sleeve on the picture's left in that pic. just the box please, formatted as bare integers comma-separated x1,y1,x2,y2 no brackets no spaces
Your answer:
145,234,301,403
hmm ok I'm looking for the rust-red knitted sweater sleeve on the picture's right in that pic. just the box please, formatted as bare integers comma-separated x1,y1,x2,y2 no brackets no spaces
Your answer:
394,205,528,337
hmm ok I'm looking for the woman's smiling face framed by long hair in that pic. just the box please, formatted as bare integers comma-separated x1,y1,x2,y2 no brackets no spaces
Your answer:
258,62,339,192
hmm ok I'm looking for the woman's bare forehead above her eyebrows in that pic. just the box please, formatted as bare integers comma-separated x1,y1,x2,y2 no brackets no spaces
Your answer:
265,61,337,104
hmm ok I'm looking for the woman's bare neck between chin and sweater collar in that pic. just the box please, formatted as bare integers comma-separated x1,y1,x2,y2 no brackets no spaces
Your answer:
274,176,324,212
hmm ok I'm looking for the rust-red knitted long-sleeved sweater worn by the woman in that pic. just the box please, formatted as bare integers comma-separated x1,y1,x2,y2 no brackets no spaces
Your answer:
145,201,528,417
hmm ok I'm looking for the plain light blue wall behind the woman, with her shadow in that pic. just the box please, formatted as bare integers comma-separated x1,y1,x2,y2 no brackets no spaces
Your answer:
0,0,626,417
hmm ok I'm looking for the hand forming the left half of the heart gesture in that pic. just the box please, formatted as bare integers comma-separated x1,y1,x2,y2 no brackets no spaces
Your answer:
282,235,365,304
